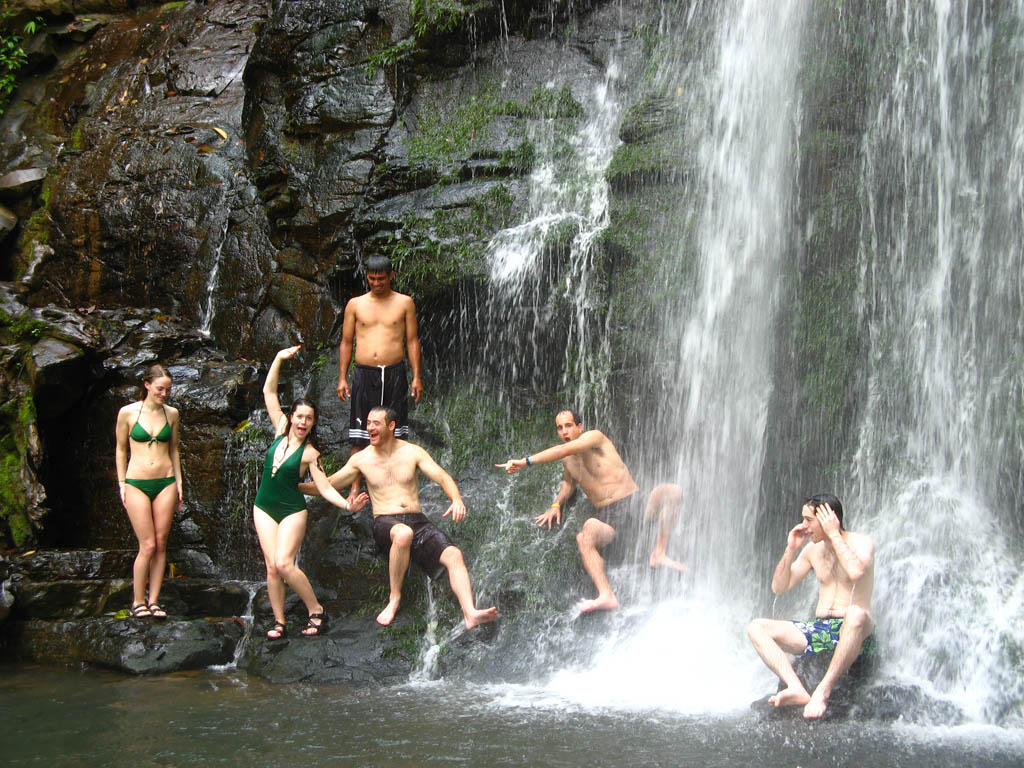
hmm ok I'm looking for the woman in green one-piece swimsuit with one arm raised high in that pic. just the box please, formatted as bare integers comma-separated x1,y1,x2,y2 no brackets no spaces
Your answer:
253,346,370,640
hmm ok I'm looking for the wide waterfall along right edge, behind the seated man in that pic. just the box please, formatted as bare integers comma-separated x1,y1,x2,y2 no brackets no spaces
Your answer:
849,0,1024,722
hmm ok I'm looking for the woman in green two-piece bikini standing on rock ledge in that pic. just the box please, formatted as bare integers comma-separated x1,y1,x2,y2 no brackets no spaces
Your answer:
115,364,182,618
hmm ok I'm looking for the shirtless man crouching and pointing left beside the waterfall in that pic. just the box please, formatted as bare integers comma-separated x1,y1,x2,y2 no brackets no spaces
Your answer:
495,411,686,613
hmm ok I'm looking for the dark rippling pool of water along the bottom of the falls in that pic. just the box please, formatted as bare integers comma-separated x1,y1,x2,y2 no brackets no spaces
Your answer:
0,667,1024,768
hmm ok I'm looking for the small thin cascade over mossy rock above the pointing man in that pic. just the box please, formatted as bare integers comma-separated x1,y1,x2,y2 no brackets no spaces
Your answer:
472,62,620,421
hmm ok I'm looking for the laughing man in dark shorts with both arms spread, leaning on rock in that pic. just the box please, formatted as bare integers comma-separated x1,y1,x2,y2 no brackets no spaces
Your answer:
299,407,498,630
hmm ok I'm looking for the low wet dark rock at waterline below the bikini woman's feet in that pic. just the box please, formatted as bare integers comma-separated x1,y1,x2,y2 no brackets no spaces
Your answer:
0,618,244,675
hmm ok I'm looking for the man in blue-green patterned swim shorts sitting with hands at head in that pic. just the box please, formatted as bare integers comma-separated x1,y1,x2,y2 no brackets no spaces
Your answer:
746,494,874,718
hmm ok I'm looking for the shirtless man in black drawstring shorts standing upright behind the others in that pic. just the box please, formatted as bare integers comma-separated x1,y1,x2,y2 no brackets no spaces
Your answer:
338,256,423,499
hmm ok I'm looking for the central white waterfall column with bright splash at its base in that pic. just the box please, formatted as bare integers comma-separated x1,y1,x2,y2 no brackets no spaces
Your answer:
536,0,806,712
